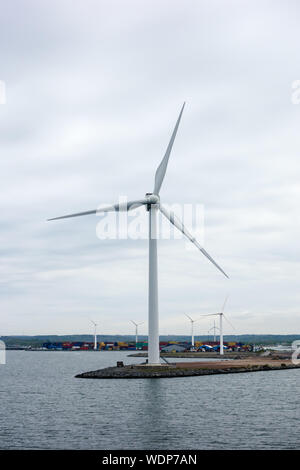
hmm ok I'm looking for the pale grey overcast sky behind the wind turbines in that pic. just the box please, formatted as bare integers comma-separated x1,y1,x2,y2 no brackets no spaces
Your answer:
0,0,300,335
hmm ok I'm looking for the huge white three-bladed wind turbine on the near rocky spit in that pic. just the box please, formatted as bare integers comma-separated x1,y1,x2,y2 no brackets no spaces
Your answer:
48,103,228,365
